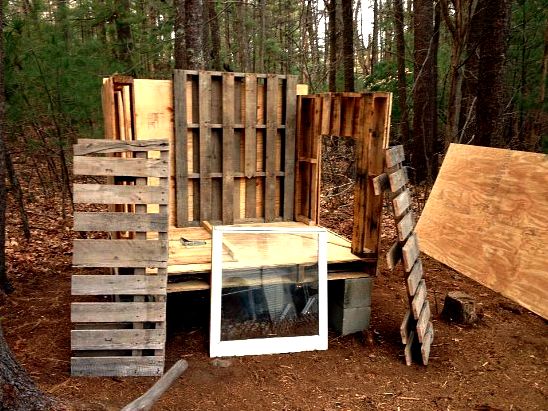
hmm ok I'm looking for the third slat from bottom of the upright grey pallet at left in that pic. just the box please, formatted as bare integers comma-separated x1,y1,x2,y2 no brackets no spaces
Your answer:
70,302,166,323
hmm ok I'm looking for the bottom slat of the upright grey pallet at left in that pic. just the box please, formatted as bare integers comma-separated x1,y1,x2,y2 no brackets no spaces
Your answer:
70,356,164,377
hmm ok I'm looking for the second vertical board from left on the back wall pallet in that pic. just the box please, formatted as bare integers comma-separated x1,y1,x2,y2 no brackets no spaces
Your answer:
198,71,212,220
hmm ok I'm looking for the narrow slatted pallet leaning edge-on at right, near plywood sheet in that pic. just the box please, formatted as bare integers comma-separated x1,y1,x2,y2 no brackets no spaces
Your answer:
373,146,434,365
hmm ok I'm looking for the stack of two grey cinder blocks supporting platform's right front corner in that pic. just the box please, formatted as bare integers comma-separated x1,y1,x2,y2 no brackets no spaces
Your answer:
328,277,373,335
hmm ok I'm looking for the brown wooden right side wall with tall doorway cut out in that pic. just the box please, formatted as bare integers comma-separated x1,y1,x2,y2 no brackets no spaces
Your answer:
295,92,392,258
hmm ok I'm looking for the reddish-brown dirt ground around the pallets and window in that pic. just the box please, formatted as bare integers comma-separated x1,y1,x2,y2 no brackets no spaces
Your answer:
0,169,548,410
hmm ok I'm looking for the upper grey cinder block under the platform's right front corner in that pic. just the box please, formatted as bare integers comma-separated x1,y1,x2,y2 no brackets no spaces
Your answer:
329,277,373,308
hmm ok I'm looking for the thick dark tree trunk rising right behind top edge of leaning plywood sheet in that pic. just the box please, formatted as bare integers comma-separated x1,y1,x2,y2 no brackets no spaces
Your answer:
476,0,511,147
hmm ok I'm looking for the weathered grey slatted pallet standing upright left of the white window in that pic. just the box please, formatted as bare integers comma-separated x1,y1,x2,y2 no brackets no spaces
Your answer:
71,139,169,376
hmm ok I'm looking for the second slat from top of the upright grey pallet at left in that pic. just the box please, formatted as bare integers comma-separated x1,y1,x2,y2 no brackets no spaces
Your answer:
74,156,169,177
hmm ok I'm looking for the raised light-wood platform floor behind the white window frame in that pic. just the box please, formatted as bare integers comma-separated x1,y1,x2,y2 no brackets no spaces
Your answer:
163,222,375,293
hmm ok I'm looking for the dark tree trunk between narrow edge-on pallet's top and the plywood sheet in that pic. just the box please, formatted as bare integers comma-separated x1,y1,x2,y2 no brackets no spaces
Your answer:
411,0,436,183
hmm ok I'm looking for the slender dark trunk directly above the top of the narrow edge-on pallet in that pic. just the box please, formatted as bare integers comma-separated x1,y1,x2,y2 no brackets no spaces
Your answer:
394,0,409,148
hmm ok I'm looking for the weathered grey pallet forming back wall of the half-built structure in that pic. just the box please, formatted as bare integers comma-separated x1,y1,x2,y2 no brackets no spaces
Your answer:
173,70,297,227
